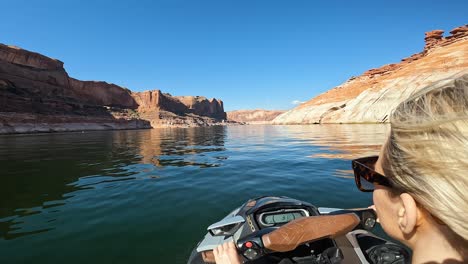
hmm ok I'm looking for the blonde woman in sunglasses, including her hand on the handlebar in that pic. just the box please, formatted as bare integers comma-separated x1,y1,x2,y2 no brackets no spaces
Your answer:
214,75,468,264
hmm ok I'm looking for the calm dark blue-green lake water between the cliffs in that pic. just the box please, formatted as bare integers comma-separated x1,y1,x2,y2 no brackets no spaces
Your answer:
0,125,388,264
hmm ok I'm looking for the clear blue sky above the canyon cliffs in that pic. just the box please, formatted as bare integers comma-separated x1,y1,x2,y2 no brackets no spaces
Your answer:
0,0,468,111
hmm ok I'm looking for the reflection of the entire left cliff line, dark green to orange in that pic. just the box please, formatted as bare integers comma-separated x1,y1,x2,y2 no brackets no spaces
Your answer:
0,127,227,239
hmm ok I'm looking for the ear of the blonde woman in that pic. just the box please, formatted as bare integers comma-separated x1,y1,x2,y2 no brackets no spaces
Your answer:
398,193,418,235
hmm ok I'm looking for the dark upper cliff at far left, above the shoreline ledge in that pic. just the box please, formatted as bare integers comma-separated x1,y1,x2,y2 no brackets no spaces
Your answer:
0,45,137,114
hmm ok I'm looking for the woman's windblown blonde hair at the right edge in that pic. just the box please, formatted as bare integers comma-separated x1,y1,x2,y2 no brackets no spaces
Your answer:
382,74,468,242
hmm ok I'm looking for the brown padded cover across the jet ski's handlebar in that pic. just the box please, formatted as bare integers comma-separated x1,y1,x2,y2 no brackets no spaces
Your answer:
262,213,360,252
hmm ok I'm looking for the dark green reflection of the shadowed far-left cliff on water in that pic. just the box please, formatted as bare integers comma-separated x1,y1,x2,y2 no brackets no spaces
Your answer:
0,133,126,239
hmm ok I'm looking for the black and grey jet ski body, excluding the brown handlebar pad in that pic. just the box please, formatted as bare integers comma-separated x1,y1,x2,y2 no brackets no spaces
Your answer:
188,196,410,264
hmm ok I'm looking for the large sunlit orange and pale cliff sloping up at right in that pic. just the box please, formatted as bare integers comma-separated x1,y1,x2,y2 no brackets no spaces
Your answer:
273,25,468,124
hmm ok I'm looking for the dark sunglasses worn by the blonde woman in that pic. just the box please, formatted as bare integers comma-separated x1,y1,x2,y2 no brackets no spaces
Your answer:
352,156,392,192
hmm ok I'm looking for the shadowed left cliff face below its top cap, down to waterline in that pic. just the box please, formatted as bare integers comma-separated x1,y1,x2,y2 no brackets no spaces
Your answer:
0,60,151,133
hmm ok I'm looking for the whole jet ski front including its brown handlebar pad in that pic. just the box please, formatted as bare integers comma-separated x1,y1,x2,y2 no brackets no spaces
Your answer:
188,196,411,264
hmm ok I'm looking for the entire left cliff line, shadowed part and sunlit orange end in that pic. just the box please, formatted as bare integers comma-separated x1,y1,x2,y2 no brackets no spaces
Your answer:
0,44,226,134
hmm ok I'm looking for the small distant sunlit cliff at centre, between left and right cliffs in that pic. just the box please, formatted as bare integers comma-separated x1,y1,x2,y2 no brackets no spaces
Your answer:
227,109,286,124
